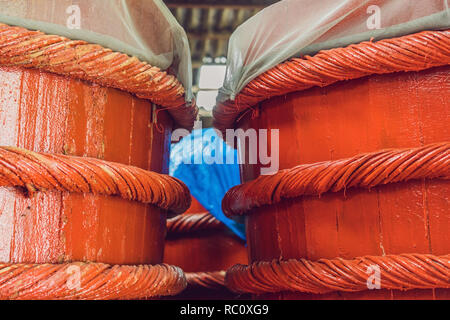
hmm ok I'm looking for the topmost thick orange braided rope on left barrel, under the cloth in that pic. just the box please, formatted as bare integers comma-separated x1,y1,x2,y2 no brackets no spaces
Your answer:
0,23,197,129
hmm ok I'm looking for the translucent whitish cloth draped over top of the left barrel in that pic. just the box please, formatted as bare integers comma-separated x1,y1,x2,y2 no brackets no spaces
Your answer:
0,0,193,102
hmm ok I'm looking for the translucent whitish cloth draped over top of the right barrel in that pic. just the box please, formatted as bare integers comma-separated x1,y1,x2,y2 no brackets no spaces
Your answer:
220,0,450,102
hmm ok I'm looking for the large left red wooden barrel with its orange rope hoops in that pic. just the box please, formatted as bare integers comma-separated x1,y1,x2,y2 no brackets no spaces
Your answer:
0,25,195,299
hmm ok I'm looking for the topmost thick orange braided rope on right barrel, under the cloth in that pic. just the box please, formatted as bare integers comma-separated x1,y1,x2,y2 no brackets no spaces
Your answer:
213,30,450,132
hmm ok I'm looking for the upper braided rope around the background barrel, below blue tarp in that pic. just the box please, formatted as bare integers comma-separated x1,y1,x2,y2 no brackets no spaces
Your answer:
167,212,223,235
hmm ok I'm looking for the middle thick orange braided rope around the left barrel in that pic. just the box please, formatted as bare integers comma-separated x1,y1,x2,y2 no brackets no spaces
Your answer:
0,147,191,213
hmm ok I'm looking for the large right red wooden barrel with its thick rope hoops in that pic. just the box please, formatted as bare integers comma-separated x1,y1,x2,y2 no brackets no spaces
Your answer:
216,31,450,299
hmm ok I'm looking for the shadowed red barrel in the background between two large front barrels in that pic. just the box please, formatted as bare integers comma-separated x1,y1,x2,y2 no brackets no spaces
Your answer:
164,198,248,300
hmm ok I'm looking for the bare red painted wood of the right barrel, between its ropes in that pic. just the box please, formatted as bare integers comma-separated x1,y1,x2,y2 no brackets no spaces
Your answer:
240,66,450,299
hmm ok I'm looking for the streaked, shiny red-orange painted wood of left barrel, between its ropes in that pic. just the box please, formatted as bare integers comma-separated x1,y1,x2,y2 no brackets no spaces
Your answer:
0,67,172,264
